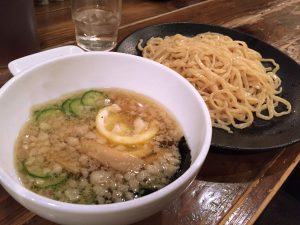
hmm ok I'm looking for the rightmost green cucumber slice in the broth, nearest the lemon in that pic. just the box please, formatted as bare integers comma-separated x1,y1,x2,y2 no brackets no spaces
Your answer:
81,90,107,108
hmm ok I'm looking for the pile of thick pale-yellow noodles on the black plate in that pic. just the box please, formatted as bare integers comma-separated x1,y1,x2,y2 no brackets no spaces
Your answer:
138,32,291,133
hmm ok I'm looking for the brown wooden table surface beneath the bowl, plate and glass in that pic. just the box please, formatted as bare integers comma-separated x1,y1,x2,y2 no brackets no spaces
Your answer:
0,0,300,225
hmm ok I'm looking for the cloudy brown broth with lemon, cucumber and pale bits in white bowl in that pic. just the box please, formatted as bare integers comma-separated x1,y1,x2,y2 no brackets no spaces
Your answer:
15,89,188,204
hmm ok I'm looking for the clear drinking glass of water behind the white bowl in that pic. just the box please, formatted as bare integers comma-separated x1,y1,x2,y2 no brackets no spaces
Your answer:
71,0,122,51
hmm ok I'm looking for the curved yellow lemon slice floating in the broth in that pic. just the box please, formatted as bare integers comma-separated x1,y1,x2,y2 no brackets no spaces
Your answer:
96,104,158,145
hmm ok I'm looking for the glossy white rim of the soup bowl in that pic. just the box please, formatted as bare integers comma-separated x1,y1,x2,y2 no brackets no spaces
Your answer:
0,52,212,214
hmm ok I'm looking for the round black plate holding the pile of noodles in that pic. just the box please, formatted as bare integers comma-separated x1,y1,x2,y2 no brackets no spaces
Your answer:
117,22,300,151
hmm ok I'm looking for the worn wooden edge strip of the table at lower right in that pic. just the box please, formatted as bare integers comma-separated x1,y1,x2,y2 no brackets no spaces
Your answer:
220,145,300,224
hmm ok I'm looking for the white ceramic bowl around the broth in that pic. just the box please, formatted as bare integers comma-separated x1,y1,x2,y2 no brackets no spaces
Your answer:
0,52,212,225
